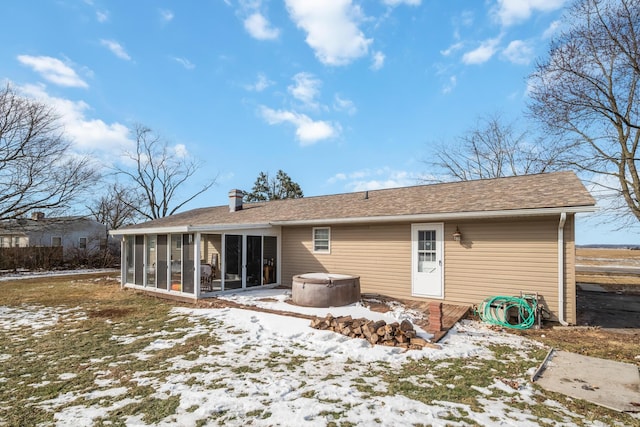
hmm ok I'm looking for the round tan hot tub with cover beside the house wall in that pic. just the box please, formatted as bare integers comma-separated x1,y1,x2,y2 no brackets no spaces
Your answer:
291,273,360,307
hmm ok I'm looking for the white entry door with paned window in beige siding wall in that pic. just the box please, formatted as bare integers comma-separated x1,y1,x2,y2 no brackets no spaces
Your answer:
411,223,444,298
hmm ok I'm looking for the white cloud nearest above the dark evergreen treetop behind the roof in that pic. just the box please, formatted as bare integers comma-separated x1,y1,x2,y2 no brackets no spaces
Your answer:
260,106,340,146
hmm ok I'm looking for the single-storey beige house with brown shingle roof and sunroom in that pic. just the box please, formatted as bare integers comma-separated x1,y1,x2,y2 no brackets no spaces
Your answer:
112,172,595,323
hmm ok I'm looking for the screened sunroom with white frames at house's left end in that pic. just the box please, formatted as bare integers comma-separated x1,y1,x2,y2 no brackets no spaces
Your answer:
114,225,280,299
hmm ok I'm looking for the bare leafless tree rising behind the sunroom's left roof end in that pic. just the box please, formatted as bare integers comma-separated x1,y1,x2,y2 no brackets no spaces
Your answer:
117,125,215,219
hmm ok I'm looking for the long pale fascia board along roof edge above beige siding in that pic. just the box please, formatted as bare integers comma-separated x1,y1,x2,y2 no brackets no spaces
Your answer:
271,206,598,226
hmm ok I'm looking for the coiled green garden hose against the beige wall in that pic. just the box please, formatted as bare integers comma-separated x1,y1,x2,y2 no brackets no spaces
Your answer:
476,296,538,329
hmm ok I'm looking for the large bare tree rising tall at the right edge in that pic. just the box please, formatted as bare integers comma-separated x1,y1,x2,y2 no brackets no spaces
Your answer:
530,0,640,220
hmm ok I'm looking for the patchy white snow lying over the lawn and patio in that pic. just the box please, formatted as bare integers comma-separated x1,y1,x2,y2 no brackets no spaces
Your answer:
0,289,608,426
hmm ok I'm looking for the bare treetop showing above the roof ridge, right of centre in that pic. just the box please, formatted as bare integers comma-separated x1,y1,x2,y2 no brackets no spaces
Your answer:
426,113,564,181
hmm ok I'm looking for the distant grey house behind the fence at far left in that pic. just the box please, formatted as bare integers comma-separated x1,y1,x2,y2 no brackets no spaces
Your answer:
0,212,107,258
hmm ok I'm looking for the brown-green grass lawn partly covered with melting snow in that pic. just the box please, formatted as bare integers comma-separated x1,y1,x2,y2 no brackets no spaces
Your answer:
0,275,640,426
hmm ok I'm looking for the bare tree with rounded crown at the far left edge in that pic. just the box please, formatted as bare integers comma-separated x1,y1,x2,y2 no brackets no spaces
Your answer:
0,85,98,219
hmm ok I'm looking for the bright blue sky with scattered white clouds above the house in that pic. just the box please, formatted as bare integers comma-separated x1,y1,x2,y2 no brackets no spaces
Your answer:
0,0,640,244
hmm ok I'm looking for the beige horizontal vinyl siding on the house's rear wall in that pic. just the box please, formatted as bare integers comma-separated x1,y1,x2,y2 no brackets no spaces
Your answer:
282,215,575,323
